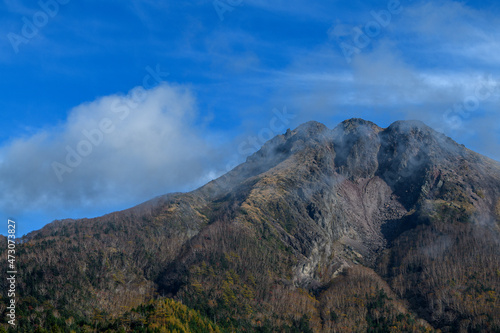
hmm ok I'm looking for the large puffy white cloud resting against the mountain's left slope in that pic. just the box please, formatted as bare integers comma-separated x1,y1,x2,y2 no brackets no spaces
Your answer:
0,84,223,222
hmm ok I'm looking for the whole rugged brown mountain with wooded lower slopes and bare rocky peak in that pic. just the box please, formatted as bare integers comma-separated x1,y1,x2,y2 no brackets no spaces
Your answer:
0,119,500,332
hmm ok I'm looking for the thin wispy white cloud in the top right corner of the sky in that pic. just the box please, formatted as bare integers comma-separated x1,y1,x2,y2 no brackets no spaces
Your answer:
396,0,500,66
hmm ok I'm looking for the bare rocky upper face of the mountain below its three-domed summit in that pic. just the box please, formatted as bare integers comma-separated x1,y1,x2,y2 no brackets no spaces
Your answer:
195,119,500,285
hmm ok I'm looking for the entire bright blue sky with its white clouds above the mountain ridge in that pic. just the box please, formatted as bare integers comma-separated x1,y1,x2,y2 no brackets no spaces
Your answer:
0,0,500,236
